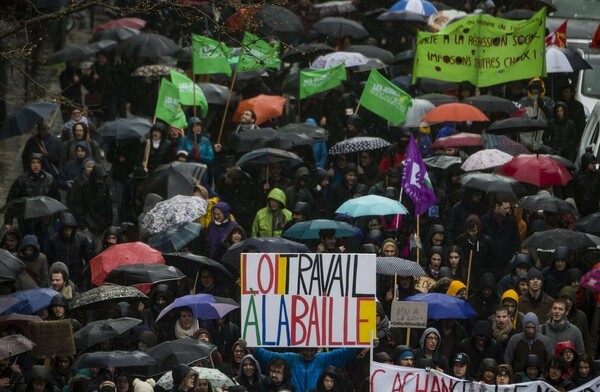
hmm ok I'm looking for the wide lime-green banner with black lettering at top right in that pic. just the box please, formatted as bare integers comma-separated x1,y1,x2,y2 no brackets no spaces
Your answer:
413,7,546,87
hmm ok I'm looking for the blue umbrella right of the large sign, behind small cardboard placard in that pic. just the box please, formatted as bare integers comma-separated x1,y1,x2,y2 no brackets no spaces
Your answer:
405,293,477,319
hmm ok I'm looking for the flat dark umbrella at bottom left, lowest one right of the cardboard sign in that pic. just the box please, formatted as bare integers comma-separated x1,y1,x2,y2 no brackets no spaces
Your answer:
73,350,157,369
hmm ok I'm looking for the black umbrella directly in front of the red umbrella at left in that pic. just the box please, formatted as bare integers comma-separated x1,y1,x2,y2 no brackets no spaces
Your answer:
104,263,185,286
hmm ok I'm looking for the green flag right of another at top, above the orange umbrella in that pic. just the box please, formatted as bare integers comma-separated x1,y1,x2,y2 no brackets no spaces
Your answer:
237,32,281,72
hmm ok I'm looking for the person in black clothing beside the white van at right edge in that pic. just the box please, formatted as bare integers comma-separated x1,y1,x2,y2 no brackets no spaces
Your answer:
542,101,579,161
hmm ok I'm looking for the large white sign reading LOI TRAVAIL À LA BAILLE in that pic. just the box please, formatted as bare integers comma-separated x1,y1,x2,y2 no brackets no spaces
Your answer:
240,253,376,347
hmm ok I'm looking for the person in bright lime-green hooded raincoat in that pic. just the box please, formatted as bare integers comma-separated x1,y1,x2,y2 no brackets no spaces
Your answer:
252,188,292,237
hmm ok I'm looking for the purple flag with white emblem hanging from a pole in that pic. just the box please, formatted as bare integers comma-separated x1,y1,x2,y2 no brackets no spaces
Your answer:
402,134,435,215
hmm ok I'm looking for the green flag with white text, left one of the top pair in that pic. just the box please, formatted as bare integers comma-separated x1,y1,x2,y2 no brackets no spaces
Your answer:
192,34,231,76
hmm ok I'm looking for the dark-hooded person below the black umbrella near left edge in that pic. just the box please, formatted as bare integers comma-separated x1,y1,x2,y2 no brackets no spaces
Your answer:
17,234,50,290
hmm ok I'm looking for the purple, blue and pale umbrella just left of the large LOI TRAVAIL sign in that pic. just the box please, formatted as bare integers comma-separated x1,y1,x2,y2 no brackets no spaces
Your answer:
156,294,240,321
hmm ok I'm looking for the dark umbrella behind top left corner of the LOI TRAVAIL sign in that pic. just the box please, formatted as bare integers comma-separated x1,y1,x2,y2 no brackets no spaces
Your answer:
221,237,310,270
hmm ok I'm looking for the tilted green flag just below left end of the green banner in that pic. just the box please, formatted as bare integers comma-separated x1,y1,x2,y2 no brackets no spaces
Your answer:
360,68,412,125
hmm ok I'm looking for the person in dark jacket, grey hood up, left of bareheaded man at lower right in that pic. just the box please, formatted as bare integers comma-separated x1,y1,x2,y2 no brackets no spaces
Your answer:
504,312,554,373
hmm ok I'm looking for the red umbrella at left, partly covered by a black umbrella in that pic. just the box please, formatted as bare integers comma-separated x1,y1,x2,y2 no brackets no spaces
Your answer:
90,242,165,286
